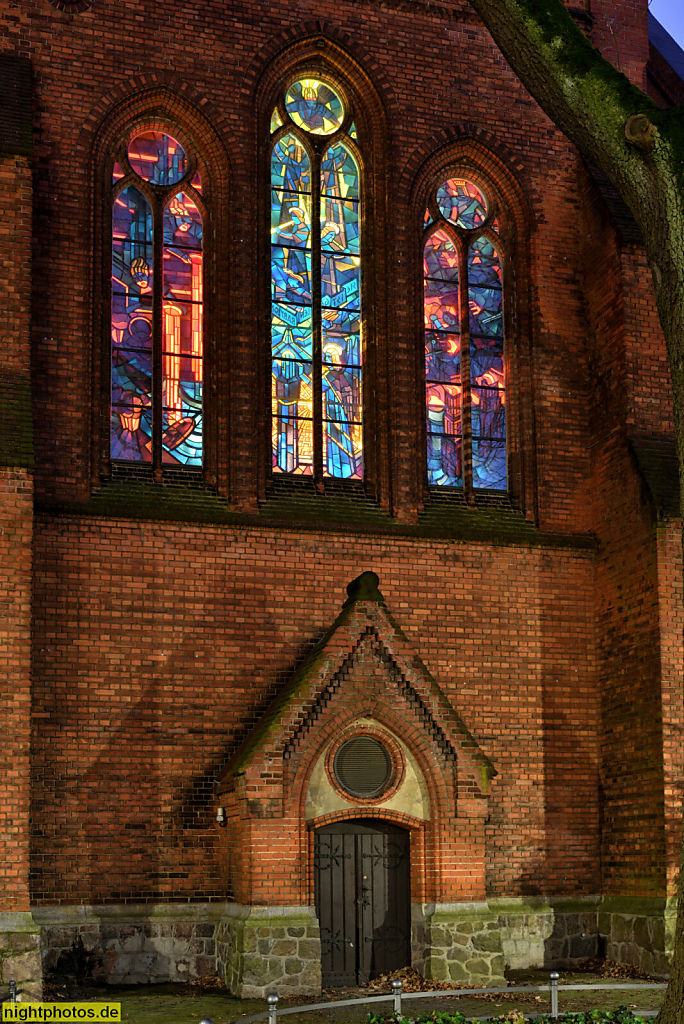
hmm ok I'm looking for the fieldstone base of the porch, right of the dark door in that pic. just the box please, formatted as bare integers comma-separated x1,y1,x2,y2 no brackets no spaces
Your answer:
412,903,506,985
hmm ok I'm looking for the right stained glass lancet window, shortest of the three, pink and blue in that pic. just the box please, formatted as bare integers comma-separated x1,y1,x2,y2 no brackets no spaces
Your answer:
423,178,506,492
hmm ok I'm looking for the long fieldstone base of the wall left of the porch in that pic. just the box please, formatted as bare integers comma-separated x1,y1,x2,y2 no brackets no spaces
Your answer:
34,903,224,985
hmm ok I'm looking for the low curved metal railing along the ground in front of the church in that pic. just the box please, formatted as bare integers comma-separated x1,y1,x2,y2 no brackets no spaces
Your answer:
237,971,668,1024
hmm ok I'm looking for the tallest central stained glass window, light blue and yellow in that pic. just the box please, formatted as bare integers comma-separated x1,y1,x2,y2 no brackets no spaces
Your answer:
270,78,364,479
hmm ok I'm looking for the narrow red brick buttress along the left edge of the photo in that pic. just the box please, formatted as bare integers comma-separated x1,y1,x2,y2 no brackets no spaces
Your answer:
0,149,33,910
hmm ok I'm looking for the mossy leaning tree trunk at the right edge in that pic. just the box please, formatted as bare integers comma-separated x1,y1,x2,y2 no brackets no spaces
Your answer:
470,0,684,1024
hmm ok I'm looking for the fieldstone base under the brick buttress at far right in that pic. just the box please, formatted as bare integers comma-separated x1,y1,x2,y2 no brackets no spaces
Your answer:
598,896,677,978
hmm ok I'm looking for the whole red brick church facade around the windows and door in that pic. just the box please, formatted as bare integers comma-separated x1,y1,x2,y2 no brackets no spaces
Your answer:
0,0,683,998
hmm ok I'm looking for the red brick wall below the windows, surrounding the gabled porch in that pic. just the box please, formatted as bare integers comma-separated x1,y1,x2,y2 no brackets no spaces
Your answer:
34,517,598,902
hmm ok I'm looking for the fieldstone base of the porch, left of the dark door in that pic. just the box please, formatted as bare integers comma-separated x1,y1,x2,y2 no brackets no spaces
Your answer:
217,903,320,999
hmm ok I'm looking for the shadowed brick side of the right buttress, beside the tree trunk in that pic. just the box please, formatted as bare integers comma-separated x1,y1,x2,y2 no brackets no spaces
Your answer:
585,169,665,895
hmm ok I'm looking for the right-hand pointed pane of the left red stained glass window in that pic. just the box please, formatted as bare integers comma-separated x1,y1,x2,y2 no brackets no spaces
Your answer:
162,193,204,466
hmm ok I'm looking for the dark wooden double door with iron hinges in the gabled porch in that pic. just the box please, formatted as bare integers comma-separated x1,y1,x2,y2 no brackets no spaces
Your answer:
313,819,411,986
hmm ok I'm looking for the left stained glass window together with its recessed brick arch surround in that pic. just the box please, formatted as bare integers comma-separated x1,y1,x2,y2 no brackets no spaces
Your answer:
90,87,232,494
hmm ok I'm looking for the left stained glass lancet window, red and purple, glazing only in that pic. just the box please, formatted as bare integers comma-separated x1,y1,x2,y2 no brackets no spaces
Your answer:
110,131,204,468
